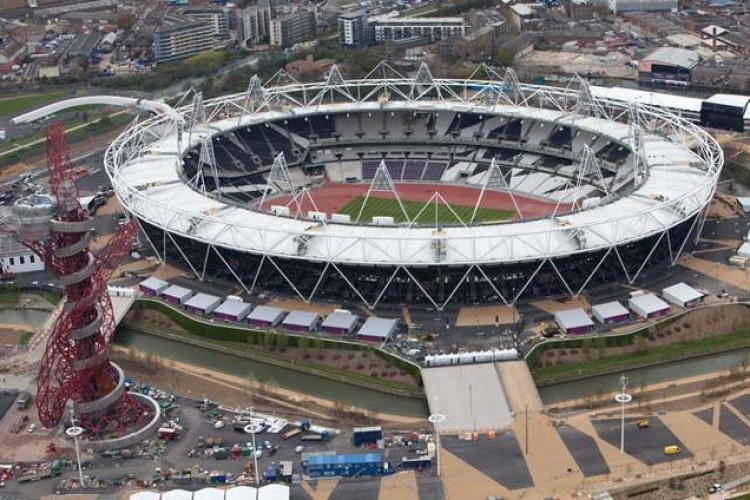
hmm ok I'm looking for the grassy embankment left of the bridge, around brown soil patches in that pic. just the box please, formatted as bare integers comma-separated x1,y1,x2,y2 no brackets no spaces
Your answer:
122,299,422,397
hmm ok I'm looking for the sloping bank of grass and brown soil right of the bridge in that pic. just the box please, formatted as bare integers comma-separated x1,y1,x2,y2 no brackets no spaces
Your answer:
526,304,750,385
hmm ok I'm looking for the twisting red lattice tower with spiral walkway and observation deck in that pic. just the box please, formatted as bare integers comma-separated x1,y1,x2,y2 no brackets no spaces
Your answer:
8,123,159,446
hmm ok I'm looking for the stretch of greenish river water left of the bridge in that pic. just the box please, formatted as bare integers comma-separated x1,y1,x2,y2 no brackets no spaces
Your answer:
111,329,429,418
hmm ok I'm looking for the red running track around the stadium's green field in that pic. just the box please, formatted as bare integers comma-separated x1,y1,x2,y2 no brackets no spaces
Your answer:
263,182,570,219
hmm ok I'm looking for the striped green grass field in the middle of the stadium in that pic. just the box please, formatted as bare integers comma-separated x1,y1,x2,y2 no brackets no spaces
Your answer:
338,196,515,225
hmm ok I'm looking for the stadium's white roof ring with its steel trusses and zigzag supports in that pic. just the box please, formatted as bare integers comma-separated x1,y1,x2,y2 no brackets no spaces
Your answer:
105,63,723,309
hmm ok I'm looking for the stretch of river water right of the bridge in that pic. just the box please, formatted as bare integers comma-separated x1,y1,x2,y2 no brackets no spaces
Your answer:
539,347,750,404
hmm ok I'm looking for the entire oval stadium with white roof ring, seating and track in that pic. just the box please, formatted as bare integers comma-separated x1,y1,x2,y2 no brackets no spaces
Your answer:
94,64,723,310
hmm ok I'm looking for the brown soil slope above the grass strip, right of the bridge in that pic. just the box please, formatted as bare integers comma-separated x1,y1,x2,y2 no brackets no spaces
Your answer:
543,305,750,366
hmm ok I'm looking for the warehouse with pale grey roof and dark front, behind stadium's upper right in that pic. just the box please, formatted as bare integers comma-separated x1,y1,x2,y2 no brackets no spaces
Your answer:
638,47,700,86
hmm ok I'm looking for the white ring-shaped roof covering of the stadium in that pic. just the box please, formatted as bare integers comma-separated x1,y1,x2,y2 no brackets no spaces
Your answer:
109,97,716,265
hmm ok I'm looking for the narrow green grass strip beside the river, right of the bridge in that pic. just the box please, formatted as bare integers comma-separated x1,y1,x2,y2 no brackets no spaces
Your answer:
531,332,750,382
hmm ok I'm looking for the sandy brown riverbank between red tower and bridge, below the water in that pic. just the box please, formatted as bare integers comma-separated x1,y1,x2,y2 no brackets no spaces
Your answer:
111,345,426,427
